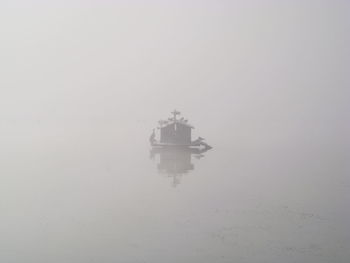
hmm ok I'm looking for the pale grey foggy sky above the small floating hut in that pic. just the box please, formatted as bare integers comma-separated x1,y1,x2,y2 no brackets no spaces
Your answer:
0,1,350,126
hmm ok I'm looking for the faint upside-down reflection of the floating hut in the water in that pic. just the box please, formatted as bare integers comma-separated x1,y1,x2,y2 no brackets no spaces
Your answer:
150,147,209,187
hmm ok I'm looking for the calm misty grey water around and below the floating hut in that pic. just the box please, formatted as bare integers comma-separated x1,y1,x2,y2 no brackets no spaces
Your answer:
0,118,350,263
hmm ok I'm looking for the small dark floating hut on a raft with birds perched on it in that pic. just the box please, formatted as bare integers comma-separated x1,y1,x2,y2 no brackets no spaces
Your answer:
149,110,212,150
